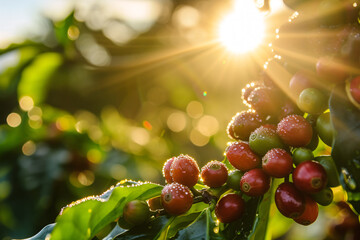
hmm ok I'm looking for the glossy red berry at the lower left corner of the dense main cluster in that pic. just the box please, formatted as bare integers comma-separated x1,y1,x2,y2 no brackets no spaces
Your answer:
240,168,270,197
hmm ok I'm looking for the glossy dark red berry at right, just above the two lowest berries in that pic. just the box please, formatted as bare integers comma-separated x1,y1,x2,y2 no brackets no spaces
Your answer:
293,160,327,193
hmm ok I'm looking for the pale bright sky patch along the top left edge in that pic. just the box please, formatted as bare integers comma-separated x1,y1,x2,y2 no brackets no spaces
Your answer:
0,0,165,48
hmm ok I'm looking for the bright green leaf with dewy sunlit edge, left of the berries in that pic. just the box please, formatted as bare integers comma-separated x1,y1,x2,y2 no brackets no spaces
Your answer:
51,182,163,240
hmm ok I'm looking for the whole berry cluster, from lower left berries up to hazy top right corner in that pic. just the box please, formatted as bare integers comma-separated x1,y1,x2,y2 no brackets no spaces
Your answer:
118,0,360,229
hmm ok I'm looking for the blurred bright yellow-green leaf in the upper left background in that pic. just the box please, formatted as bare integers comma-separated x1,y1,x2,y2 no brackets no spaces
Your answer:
18,53,63,104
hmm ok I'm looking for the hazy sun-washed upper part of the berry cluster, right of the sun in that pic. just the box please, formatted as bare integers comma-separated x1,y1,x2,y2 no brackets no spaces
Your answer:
272,0,360,111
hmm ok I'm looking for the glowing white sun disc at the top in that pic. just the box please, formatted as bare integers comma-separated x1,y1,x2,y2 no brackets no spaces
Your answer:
218,0,265,53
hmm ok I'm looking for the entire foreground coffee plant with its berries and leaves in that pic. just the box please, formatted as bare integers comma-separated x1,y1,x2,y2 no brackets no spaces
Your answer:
21,0,360,240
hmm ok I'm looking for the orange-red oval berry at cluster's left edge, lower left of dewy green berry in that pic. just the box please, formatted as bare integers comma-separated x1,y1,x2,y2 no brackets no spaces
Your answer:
226,142,261,171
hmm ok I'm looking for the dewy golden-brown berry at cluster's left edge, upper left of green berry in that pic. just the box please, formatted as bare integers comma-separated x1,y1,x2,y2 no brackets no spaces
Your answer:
227,110,263,141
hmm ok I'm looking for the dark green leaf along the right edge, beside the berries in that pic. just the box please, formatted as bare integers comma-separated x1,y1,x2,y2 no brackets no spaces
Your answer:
329,86,360,213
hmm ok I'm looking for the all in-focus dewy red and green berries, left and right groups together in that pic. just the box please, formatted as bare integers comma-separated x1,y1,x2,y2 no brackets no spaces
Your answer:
153,77,339,225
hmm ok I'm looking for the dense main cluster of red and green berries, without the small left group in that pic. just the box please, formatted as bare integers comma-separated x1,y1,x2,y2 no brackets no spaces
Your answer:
225,64,339,225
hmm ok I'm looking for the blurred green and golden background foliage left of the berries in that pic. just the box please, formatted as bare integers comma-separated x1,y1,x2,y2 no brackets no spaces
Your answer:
0,0,352,239
